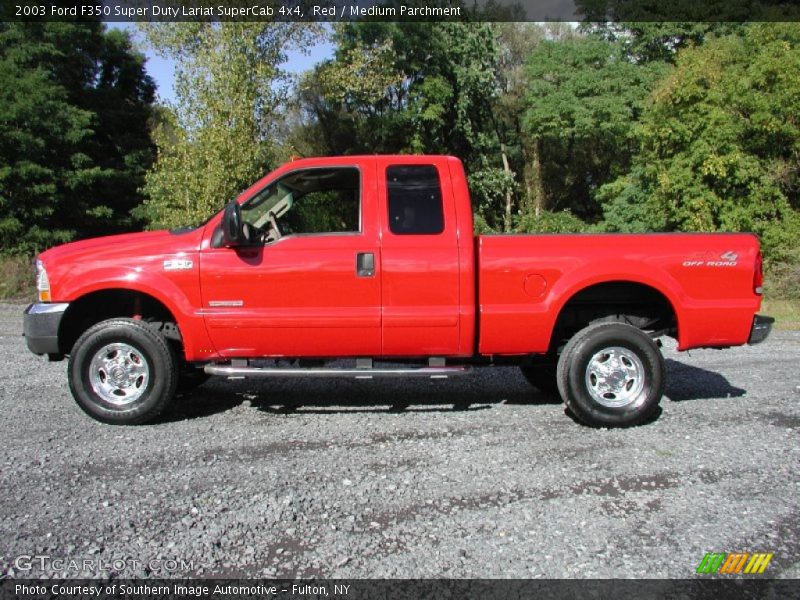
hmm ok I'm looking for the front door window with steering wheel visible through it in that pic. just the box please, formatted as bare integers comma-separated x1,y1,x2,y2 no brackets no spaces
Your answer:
242,167,361,242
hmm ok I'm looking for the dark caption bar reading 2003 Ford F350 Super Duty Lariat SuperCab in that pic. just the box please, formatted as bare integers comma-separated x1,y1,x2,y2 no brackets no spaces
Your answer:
0,0,800,23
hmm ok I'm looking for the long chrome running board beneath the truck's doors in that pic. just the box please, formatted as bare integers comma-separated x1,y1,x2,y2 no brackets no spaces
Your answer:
204,365,469,379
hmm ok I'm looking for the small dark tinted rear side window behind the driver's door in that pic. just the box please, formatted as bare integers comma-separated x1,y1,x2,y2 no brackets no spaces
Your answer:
386,165,444,235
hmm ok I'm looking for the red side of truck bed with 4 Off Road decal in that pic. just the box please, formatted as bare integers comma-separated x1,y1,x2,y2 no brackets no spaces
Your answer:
476,234,760,355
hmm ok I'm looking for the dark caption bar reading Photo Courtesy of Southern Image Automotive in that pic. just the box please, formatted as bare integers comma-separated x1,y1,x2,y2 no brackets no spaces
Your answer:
0,576,800,600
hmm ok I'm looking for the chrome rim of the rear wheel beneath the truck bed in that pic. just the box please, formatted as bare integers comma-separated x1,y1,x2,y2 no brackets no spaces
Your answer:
586,346,645,408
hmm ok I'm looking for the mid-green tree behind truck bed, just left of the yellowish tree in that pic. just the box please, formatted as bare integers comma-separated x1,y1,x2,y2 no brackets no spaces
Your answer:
523,36,667,221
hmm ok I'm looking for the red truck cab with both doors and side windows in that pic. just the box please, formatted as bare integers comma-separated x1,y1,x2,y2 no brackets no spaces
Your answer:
199,157,475,358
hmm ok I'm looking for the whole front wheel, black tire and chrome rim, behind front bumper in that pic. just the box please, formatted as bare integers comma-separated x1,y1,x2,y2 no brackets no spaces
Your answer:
68,319,178,425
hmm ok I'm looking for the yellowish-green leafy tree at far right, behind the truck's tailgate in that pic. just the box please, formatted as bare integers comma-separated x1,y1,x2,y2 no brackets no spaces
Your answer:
599,23,800,261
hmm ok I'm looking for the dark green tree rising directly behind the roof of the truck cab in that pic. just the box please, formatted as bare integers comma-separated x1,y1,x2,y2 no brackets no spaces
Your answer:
301,22,516,229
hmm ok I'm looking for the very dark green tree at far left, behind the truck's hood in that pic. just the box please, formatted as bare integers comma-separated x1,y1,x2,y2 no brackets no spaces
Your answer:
0,22,155,253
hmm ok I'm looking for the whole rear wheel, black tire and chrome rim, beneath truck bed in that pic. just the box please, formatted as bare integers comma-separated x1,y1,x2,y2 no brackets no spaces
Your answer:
557,323,666,427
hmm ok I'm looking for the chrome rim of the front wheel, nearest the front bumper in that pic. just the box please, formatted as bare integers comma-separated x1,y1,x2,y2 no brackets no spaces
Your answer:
89,343,150,406
